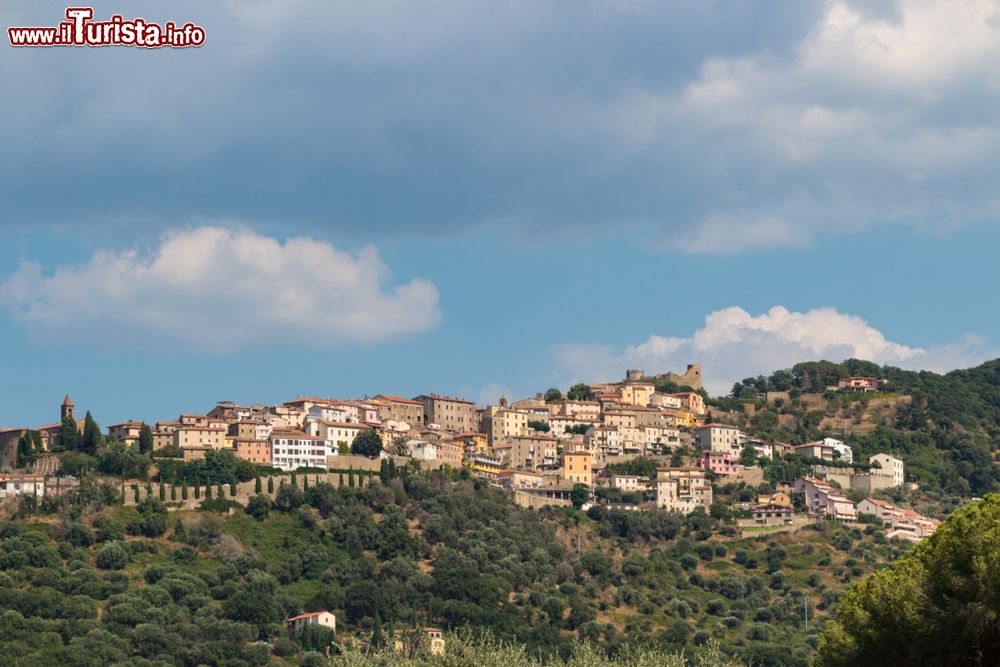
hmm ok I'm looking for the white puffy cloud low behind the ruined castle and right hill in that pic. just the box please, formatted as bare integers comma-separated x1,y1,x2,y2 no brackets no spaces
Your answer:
553,306,1000,394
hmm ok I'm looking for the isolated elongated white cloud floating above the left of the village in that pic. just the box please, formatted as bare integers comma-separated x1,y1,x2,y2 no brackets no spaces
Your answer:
0,227,439,352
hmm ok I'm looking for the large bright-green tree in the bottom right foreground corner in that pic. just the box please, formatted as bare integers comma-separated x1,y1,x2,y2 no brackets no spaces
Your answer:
815,495,1000,667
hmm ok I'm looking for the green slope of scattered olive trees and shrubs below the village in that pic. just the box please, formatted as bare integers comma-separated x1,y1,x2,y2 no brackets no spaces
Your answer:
0,464,907,665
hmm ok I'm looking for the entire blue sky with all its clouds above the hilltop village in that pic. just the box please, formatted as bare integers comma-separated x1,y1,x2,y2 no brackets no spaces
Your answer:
0,0,1000,426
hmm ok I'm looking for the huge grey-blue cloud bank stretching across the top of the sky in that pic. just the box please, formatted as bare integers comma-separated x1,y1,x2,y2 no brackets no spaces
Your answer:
0,0,1000,253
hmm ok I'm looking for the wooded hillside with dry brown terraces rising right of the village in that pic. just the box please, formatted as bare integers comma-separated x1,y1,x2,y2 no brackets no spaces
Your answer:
711,359,1000,499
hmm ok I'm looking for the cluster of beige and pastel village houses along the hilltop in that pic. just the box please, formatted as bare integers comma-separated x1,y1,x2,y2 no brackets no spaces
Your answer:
0,365,932,539
